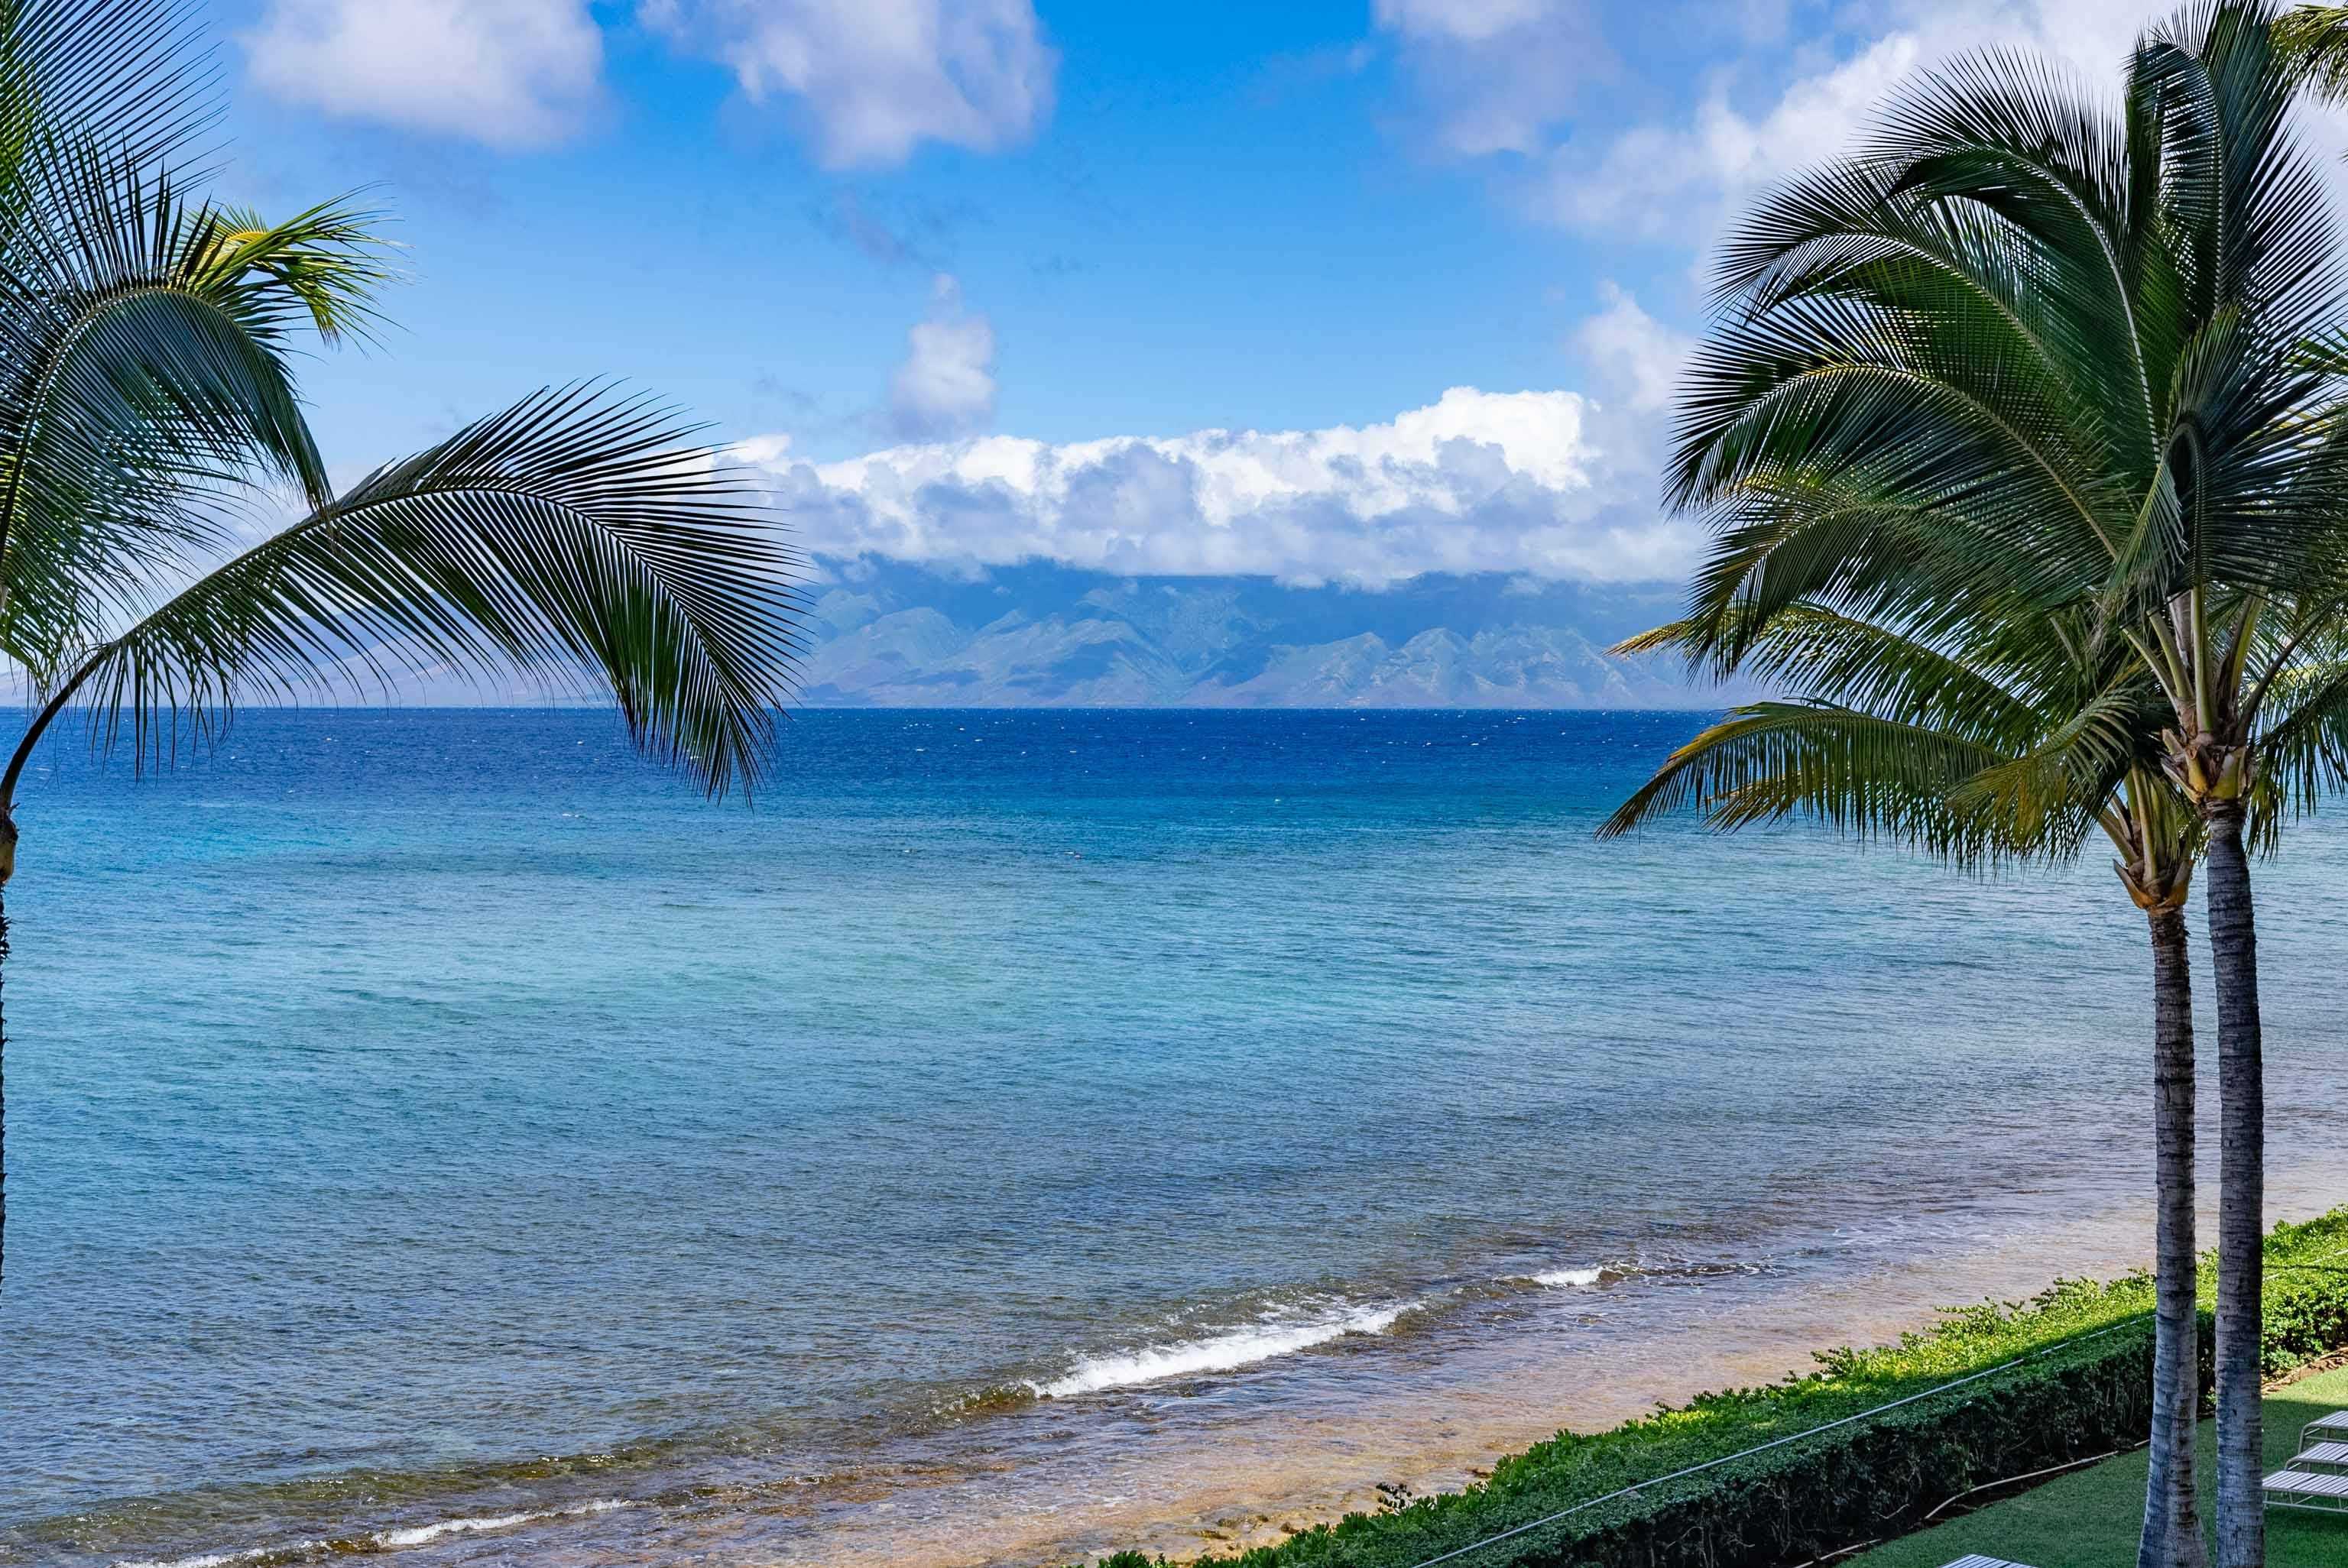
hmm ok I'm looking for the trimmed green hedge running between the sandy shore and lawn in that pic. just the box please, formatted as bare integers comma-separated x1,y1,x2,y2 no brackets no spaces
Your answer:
1101,1209,2348,1568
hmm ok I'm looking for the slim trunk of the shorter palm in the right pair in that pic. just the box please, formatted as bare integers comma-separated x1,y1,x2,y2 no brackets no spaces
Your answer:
2137,909,2210,1568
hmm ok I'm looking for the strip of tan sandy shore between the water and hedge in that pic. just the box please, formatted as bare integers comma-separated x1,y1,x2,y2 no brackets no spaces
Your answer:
732,1165,2348,1568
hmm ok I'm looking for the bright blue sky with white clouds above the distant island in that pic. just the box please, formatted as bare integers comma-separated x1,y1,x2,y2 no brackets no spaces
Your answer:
211,0,2244,587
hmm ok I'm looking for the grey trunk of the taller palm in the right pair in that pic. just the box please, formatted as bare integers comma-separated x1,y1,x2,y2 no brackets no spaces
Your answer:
2205,801,2265,1568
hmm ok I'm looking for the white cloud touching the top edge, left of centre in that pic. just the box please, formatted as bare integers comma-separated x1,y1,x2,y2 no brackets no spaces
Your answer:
641,0,1059,169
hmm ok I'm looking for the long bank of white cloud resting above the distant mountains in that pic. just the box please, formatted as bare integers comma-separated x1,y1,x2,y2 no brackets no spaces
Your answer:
744,382,1700,587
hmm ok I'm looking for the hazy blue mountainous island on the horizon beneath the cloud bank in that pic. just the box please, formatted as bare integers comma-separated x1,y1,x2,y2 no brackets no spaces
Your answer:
801,561,1735,709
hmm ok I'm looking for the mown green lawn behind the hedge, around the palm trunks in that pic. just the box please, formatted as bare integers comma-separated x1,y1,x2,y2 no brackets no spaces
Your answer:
1850,1369,2348,1568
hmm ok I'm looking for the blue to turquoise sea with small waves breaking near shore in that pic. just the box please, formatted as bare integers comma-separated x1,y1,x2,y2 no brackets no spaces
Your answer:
0,711,2348,1566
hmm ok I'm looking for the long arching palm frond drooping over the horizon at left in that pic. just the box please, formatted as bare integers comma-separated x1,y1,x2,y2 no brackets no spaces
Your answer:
0,385,817,812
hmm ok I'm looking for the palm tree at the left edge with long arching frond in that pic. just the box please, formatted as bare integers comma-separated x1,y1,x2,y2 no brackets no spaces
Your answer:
0,0,796,1286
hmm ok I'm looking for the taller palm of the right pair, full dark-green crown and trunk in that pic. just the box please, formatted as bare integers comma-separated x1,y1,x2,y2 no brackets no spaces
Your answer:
1624,0,2348,1568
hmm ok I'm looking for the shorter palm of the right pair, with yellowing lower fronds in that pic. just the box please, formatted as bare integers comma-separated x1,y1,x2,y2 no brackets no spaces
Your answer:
1599,479,2205,1568
